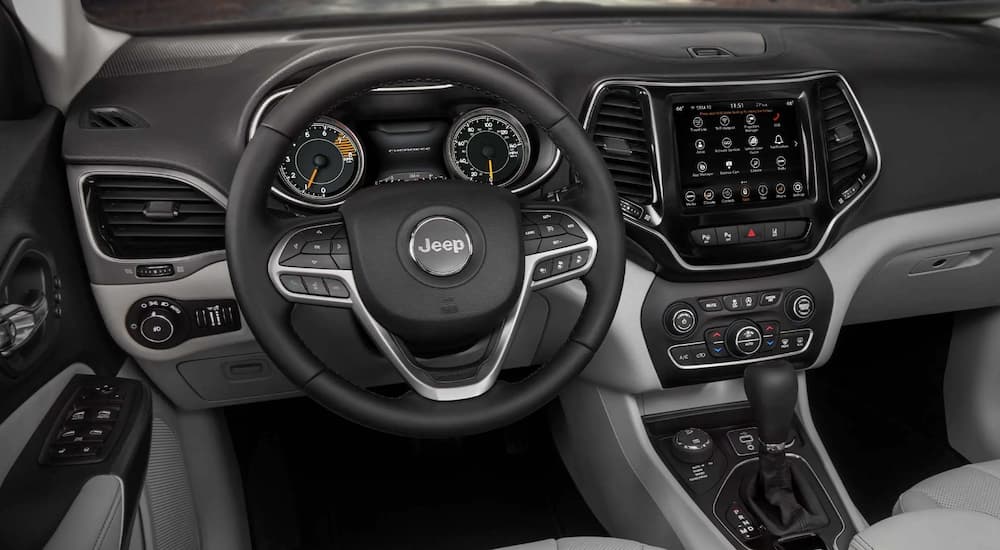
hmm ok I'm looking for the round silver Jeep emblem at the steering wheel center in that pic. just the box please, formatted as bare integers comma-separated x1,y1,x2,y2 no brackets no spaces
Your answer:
410,216,472,277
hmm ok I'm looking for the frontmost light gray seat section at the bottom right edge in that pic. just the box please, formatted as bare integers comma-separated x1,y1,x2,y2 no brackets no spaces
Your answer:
850,509,1000,550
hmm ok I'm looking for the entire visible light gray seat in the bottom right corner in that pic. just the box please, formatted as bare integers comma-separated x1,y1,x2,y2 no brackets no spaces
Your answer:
851,460,1000,550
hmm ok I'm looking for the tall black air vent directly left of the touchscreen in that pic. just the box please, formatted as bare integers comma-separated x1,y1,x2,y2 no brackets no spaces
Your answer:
591,88,656,205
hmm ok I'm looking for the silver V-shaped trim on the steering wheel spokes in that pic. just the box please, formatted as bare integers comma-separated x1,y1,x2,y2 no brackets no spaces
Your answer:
268,208,597,401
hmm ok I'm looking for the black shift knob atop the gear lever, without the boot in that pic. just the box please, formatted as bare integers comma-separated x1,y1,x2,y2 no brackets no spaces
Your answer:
743,361,799,445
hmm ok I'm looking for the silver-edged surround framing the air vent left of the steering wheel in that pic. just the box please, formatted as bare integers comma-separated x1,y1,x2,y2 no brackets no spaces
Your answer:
66,165,229,284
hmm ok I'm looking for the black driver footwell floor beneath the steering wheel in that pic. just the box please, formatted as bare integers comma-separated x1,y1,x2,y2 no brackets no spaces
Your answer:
227,399,605,550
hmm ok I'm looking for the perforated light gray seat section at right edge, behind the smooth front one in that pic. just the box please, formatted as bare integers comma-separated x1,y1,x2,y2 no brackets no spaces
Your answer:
893,460,1000,520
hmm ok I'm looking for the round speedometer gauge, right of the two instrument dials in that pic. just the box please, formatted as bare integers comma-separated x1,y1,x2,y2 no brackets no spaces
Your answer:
446,107,531,186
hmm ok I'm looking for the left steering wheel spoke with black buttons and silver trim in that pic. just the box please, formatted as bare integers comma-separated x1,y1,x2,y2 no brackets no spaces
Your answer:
268,221,357,308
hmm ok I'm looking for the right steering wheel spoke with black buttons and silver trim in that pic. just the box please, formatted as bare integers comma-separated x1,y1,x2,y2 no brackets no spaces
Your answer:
521,206,597,290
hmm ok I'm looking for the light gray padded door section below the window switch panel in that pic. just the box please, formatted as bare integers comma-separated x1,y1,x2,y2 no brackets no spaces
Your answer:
44,475,125,550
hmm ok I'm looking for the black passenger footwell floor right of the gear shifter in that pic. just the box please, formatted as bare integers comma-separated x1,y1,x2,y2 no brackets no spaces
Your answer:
807,315,967,523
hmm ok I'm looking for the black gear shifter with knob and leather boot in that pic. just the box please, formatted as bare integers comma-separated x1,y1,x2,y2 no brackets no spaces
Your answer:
741,362,829,536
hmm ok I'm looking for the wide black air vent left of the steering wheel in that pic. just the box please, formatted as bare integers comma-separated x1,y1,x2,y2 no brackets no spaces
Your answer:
84,175,226,259
